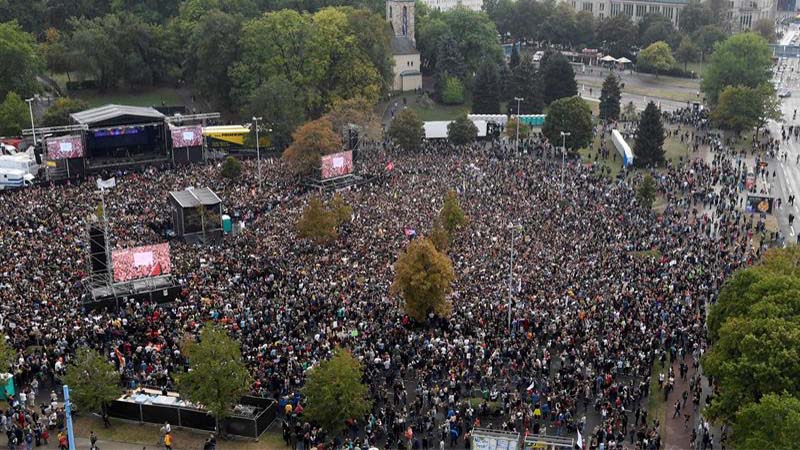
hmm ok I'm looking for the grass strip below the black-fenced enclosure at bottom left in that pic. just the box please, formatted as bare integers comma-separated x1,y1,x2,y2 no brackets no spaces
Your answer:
71,415,287,450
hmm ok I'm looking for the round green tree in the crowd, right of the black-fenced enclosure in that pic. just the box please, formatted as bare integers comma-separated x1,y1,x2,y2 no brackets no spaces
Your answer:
303,349,372,434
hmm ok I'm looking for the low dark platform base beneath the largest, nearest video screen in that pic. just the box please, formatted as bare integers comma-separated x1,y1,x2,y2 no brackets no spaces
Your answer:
81,275,180,311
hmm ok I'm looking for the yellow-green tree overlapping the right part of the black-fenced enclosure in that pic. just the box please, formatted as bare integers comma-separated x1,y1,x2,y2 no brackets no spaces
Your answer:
177,323,252,430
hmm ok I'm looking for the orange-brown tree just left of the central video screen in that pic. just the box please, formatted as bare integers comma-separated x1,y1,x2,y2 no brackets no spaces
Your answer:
283,119,342,175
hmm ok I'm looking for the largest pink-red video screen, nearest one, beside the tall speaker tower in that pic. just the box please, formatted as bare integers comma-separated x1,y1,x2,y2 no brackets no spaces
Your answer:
111,242,172,281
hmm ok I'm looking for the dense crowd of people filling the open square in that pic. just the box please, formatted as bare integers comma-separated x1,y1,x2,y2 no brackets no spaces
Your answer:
0,131,762,449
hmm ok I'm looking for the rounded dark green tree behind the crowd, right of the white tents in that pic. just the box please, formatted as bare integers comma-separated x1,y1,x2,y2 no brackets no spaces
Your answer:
542,97,592,153
